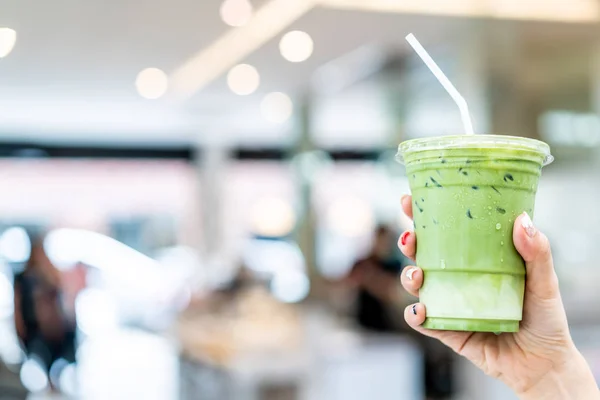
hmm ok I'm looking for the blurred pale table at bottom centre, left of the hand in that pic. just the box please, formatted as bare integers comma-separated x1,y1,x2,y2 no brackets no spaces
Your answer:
180,298,423,400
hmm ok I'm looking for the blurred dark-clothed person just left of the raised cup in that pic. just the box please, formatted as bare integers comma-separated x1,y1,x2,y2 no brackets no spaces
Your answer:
346,225,403,333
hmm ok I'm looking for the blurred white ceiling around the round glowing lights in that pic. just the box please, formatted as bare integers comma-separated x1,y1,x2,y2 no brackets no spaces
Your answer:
0,0,596,143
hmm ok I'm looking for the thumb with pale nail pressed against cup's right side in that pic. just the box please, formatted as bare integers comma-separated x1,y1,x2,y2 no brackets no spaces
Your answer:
513,213,559,299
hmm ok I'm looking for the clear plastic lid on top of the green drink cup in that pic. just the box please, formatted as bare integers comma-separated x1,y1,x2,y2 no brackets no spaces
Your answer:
396,135,554,166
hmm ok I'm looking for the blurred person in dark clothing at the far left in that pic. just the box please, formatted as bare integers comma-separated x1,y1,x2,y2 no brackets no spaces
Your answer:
14,237,75,389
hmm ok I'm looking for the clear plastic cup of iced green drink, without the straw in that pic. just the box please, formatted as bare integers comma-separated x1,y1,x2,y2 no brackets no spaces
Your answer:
398,135,553,332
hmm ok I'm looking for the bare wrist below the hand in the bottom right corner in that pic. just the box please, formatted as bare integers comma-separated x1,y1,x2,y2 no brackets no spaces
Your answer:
519,347,600,400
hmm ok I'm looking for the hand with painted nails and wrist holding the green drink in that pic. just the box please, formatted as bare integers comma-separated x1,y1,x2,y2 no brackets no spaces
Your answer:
398,196,600,399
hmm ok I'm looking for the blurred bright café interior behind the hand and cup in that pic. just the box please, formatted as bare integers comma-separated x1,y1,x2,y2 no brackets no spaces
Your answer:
0,0,600,400
